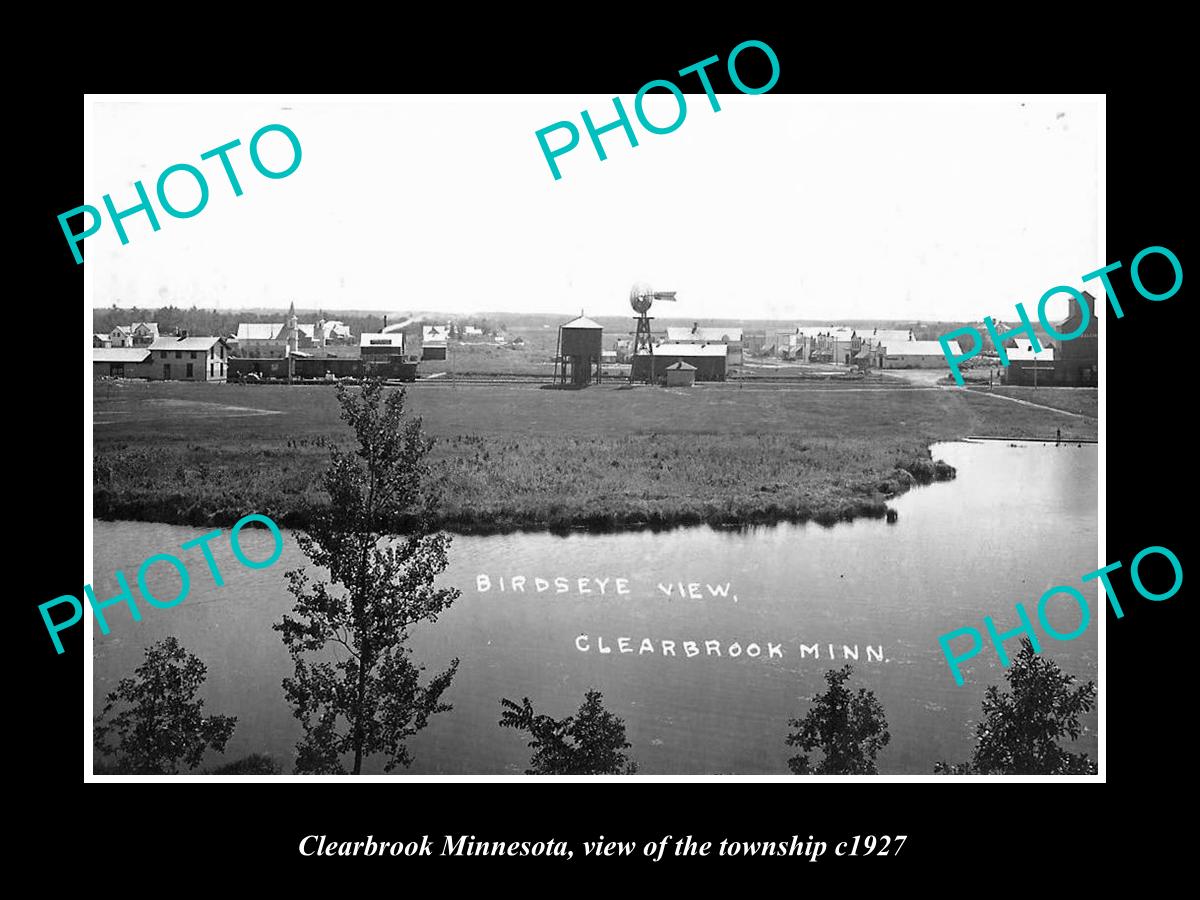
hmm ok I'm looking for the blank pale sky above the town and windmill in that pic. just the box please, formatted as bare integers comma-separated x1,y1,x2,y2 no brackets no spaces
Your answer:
84,94,1111,320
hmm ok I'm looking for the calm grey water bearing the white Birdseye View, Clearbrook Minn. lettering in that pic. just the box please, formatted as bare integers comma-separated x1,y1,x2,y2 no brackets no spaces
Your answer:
92,442,1103,774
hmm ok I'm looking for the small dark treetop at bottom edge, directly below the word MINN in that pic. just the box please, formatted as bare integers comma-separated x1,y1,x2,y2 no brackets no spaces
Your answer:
787,665,892,775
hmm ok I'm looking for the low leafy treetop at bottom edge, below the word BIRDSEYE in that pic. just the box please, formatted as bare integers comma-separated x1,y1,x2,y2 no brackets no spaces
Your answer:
500,690,637,775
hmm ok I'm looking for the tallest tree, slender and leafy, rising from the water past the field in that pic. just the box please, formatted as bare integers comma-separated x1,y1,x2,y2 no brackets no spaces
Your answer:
275,379,458,775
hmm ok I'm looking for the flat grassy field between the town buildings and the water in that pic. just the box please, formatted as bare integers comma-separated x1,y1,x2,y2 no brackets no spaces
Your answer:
94,383,1096,533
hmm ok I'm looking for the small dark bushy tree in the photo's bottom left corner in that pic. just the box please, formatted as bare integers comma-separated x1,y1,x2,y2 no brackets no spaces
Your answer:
95,637,238,775
